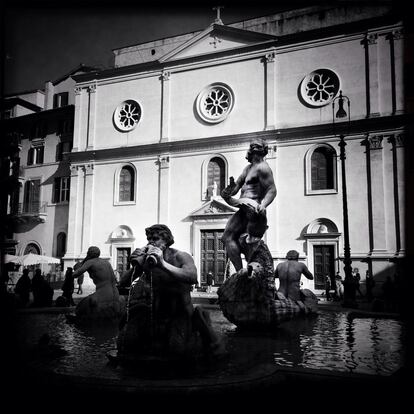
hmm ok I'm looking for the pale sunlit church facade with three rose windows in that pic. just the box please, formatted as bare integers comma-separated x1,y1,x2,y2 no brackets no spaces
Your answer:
57,6,410,291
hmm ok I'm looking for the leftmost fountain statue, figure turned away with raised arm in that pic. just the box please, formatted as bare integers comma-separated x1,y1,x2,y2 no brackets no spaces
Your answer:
68,246,125,322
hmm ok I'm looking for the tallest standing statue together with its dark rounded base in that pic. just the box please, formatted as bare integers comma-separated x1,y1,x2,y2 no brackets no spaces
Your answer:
217,140,317,329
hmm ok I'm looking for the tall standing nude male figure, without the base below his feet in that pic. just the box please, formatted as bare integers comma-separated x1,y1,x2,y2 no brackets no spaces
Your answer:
221,139,276,271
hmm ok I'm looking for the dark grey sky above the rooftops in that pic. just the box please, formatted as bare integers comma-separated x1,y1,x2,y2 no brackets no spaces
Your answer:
2,0,324,95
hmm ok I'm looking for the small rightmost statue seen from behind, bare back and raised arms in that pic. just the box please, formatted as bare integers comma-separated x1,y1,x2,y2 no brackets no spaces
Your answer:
275,250,313,301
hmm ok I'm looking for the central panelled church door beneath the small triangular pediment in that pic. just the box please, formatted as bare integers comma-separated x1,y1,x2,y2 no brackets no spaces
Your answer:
200,230,227,285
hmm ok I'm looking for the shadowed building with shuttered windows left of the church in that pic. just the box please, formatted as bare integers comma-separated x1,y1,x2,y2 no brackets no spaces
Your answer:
2,65,97,278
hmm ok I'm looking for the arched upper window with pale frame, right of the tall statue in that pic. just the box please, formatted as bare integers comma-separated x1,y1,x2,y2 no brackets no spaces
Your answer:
305,144,337,195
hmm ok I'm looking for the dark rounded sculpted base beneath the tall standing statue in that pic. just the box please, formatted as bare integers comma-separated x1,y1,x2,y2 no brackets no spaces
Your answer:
217,244,318,330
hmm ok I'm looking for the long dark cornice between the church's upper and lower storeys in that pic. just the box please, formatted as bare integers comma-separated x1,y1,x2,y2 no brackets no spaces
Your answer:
68,115,413,163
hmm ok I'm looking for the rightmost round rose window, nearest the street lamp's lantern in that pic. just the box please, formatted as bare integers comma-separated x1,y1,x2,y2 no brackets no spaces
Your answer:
300,69,340,107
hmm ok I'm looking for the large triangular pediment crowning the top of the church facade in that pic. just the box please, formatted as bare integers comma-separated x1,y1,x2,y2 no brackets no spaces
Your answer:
160,23,276,62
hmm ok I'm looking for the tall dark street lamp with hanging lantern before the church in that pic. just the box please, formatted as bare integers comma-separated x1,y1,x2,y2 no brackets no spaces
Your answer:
332,91,357,308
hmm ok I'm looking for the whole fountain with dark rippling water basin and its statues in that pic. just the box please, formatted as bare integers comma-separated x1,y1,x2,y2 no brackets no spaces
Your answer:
2,142,406,408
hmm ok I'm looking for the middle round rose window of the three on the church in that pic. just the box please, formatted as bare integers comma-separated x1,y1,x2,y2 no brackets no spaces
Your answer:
197,83,234,124
